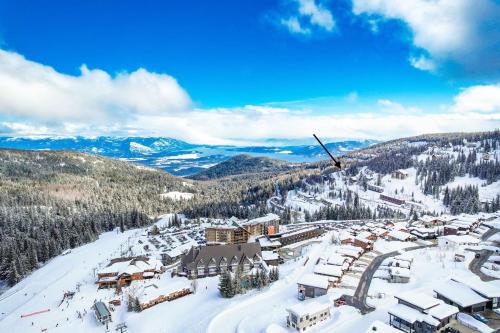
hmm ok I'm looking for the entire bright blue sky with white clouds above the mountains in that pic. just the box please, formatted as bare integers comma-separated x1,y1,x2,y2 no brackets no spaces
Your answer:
0,0,500,144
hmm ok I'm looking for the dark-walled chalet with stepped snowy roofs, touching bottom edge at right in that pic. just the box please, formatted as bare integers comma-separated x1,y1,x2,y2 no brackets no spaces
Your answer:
388,292,458,333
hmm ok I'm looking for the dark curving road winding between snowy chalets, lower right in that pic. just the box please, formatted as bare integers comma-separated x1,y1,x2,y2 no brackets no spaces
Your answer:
343,244,436,314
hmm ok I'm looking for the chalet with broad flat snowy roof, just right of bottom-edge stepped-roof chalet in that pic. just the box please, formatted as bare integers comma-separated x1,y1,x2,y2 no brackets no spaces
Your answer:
434,280,489,313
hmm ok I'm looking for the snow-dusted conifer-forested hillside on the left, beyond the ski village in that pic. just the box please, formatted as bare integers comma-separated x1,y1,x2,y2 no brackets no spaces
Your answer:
0,150,314,284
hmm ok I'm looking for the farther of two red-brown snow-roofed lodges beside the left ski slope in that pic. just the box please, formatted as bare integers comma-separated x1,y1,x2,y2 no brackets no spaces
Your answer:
96,257,162,288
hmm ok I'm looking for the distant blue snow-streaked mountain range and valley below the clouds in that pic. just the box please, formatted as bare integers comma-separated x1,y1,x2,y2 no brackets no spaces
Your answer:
0,136,377,176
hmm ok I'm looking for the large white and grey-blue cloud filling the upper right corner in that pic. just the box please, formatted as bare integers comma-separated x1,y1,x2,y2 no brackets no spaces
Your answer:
352,0,500,75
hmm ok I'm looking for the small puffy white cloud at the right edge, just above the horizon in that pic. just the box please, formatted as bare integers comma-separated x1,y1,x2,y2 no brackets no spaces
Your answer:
452,84,500,114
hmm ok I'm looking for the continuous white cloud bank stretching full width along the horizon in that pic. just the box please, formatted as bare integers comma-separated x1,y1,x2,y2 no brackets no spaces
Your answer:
0,51,500,144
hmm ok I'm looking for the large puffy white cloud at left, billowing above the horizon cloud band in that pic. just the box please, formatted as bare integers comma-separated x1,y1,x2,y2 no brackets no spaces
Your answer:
0,50,190,123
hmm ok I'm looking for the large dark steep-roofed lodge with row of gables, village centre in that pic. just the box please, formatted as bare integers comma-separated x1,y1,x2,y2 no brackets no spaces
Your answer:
177,242,262,278
